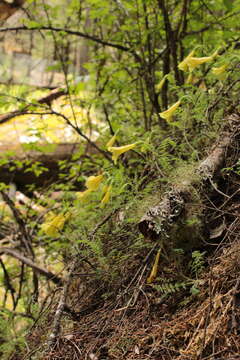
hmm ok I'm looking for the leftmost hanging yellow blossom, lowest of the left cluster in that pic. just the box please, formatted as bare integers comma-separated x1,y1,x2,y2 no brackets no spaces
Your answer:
41,213,71,237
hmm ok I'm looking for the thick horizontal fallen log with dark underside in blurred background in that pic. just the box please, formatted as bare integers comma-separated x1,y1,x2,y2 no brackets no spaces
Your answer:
0,143,96,191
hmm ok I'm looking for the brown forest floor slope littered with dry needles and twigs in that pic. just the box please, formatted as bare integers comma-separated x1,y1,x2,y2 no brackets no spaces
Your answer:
22,114,240,360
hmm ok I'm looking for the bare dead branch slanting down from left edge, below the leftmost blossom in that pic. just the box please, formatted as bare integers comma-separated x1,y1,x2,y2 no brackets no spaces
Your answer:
0,246,63,285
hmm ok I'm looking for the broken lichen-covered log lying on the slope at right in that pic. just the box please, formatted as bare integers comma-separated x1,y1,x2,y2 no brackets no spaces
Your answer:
138,114,240,245
